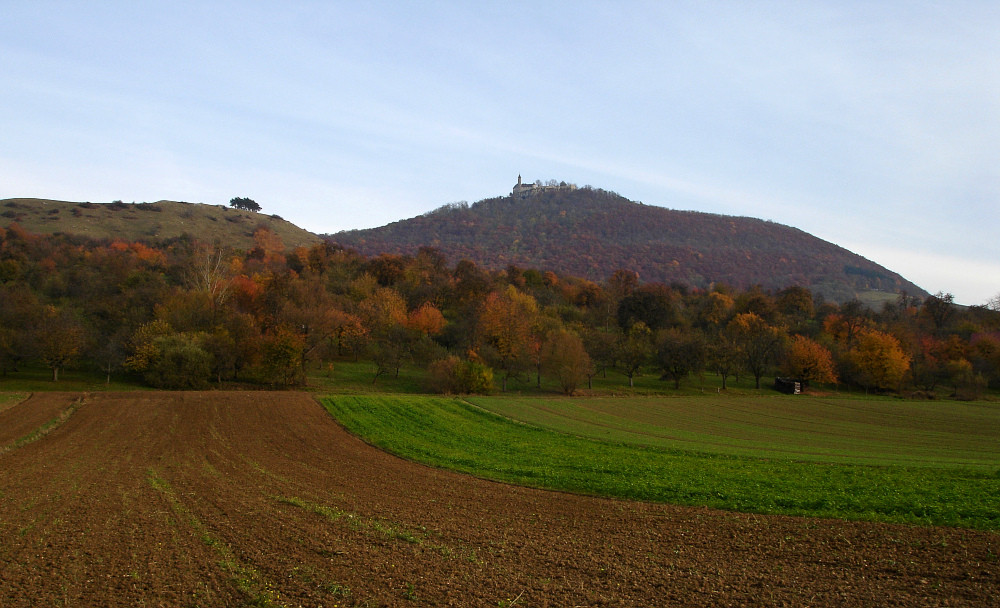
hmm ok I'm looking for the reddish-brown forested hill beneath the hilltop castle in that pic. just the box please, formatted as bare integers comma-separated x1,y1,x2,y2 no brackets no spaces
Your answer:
327,188,926,301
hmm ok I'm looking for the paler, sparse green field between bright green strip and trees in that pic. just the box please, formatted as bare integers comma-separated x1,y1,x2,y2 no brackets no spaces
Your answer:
468,395,1000,469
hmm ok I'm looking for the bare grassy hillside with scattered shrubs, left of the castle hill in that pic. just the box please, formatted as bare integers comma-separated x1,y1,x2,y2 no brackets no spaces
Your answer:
0,198,320,249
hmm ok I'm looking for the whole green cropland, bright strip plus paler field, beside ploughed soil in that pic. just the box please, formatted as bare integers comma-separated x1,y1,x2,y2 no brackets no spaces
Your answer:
321,395,1000,530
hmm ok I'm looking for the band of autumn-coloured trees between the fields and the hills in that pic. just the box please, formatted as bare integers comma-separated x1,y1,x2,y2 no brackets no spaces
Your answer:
0,225,1000,399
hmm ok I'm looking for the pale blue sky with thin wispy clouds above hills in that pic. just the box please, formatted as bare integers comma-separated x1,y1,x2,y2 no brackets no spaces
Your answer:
0,0,1000,305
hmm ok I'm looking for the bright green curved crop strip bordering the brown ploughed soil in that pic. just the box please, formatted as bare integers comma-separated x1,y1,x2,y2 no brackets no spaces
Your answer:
321,395,1000,530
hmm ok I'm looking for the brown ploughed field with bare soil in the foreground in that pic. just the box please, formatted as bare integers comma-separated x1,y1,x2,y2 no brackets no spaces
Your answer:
0,392,1000,608
